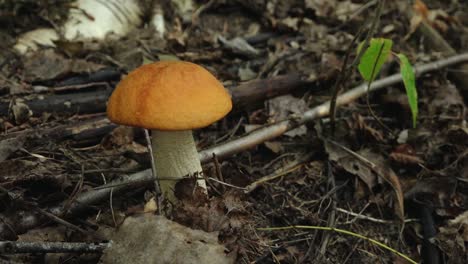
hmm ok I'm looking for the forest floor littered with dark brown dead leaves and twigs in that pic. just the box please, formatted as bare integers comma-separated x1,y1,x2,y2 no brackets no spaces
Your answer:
0,0,468,263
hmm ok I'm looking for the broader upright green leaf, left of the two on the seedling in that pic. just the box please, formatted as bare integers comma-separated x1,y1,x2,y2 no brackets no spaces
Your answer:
358,38,393,82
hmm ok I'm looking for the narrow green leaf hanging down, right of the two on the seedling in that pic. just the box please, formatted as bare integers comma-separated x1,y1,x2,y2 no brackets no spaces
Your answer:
398,53,418,127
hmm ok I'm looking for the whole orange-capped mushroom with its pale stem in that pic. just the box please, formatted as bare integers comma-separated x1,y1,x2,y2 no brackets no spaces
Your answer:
107,61,232,202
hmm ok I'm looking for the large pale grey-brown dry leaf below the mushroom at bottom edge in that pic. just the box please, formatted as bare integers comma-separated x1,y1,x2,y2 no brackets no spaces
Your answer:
101,214,234,264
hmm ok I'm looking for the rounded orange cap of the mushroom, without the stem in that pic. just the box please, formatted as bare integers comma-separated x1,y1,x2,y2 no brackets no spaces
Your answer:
107,61,232,130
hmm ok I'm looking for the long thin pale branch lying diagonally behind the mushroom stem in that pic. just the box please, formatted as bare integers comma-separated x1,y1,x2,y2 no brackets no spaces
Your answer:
0,53,468,237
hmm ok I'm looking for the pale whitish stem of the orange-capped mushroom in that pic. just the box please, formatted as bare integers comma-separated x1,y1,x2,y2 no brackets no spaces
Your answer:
151,130,206,201
